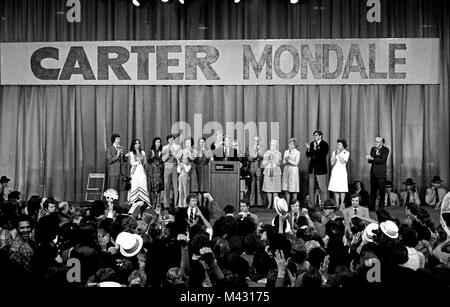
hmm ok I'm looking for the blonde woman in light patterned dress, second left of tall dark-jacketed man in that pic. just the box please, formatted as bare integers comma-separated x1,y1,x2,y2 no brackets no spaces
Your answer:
261,140,281,209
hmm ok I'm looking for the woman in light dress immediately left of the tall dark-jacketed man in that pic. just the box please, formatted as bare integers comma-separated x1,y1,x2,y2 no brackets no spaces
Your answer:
281,138,300,204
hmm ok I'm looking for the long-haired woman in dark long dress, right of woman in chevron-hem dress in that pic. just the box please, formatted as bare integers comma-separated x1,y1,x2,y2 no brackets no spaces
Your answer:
147,137,164,205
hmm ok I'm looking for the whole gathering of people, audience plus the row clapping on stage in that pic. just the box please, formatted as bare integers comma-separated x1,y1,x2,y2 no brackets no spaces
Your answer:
0,131,450,289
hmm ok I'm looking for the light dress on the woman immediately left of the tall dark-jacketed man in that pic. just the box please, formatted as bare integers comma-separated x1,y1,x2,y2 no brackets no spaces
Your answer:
281,148,300,193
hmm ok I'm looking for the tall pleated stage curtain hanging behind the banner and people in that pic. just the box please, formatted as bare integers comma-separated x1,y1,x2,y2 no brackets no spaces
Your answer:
0,0,450,200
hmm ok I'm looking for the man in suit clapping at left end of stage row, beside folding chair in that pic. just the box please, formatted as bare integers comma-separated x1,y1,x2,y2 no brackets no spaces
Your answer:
106,133,124,193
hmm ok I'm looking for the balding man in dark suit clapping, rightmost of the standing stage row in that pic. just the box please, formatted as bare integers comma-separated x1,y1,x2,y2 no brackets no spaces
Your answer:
366,136,389,210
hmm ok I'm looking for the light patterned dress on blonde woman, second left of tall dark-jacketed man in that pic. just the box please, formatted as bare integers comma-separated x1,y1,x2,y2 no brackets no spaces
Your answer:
261,150,281,193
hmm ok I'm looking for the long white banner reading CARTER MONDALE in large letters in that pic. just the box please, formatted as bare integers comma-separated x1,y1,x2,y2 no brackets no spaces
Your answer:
0,38,440,85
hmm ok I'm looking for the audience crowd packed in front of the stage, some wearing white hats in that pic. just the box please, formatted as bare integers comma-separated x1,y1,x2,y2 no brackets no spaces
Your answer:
0,185,450,289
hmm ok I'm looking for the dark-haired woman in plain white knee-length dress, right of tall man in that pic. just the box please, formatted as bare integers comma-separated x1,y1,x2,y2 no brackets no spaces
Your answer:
328,139,350,211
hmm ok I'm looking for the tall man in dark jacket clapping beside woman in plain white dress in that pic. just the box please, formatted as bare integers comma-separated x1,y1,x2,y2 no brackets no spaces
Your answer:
305,130,329,207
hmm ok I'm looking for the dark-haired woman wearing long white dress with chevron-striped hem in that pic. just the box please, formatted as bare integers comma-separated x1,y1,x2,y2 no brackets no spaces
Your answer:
126,139,150,205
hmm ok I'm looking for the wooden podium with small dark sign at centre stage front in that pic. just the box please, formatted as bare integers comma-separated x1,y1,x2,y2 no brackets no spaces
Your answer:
209,161,240,212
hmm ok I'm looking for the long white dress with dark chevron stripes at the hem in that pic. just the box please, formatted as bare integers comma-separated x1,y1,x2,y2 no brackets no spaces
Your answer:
128,151,150,205
